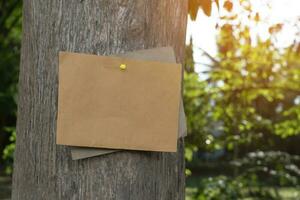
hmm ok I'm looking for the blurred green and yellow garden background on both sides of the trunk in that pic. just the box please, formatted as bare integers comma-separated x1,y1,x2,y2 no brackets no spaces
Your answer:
0,0,300,200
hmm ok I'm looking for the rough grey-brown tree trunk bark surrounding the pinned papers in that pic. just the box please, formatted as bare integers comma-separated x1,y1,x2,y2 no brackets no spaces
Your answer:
12,0,187,200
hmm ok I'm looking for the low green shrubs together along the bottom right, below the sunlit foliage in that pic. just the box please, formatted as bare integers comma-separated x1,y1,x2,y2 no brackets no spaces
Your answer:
195,151,300,200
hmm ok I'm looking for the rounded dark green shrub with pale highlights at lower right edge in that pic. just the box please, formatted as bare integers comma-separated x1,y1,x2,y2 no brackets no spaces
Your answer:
232,151,300,186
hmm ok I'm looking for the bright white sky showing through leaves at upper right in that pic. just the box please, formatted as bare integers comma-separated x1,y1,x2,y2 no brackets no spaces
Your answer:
186,0,300,79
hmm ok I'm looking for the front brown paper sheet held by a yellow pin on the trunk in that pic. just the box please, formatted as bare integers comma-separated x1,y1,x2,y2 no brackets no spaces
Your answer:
57,48,181,152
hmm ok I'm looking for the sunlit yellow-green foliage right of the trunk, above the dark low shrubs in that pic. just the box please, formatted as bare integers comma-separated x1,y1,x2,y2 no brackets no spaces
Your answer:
184,1,300,156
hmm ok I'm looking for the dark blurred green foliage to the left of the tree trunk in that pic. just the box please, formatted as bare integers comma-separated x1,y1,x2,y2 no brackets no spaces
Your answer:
0,0,22,173
